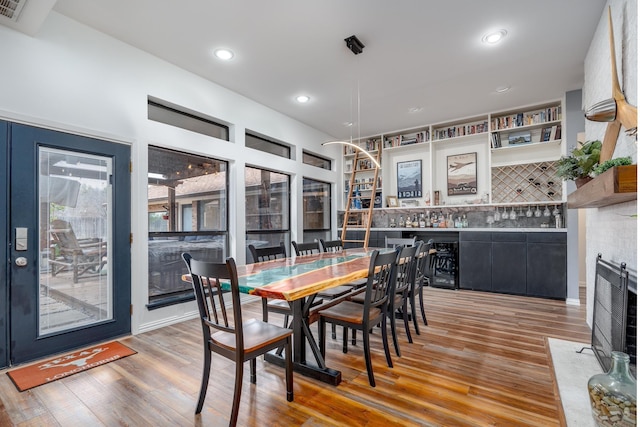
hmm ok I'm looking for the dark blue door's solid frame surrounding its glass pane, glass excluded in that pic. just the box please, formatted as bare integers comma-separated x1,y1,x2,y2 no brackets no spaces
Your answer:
6,123,131,364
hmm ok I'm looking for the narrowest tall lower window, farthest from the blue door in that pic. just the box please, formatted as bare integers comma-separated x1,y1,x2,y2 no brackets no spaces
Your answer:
302,178,331,241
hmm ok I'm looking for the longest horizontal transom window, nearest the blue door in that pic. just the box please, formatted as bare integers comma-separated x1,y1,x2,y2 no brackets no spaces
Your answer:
147,96,229,141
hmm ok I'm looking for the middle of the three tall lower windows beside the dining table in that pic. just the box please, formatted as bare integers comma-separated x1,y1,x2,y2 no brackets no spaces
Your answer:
245,166,290,262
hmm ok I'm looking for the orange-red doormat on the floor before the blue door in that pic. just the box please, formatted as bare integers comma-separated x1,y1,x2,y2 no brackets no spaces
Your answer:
7,341,137,391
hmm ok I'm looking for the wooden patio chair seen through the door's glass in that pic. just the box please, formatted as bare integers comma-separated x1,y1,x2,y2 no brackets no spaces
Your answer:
49,219,107,283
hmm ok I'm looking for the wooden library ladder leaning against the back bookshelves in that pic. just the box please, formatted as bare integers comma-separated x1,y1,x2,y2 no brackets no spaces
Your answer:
341,149,382,248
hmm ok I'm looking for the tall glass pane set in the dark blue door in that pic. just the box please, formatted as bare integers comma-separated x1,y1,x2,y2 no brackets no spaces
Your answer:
38,147,113,335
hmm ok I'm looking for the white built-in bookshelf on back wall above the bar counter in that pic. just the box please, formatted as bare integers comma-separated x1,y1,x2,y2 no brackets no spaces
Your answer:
343,100,566,207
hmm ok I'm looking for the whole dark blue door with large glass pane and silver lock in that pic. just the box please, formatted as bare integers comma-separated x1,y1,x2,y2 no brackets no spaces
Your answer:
6,123,131,364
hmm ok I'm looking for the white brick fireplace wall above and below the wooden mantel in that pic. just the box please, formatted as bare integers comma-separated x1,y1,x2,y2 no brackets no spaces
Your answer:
583,0,638,325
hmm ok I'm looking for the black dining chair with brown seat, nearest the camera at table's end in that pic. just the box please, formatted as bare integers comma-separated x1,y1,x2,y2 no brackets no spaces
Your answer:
182,253,293,426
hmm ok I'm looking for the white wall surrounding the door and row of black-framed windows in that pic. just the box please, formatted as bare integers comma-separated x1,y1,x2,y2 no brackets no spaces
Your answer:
0,12,341,333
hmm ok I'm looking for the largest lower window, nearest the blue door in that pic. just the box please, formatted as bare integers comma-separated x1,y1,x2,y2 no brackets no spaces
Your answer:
147,147,229,308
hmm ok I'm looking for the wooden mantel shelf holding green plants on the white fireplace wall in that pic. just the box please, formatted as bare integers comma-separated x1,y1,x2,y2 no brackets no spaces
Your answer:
567,165,638,209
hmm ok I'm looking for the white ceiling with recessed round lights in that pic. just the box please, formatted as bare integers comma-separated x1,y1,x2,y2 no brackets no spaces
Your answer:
11,0,606,138
